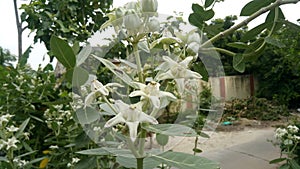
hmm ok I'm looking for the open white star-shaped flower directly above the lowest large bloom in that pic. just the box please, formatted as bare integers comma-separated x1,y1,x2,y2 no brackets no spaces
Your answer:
129,81,176,109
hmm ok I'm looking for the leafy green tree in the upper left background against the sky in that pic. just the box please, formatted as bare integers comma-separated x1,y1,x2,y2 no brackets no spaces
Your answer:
21,0,112,54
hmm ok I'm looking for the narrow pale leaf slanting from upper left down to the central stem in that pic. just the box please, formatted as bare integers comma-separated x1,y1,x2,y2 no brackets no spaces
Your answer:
94,55,134,87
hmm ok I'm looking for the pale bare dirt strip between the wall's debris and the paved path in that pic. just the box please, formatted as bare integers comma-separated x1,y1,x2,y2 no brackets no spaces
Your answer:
166,119,286,154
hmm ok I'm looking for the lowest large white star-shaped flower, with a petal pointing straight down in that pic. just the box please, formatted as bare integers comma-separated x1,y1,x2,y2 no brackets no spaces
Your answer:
104,100,158,141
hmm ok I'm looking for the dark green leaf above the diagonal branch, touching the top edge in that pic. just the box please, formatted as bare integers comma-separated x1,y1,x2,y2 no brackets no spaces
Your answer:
240,0,275,16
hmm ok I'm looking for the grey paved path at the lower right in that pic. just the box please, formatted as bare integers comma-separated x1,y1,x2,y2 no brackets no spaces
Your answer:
200,129,280,169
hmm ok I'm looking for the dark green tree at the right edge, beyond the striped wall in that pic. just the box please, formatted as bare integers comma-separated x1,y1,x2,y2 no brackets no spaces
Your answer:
250,25,300,108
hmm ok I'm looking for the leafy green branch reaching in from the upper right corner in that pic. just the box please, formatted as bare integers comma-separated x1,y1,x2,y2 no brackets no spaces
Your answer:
189,0,299,72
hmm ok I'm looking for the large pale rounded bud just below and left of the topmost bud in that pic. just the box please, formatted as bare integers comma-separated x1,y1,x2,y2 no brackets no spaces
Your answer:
124,12,142,34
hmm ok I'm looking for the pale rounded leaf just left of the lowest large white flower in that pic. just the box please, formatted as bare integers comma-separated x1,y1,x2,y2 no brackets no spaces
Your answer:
76,107,100,124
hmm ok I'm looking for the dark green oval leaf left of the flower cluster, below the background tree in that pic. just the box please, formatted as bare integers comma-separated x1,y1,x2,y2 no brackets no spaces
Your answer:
50,35,76,69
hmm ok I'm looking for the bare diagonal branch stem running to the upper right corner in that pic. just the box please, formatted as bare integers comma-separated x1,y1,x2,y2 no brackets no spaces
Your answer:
200,0,300,48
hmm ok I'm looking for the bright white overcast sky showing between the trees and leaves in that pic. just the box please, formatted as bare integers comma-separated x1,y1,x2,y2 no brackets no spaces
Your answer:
0,0,300,69
